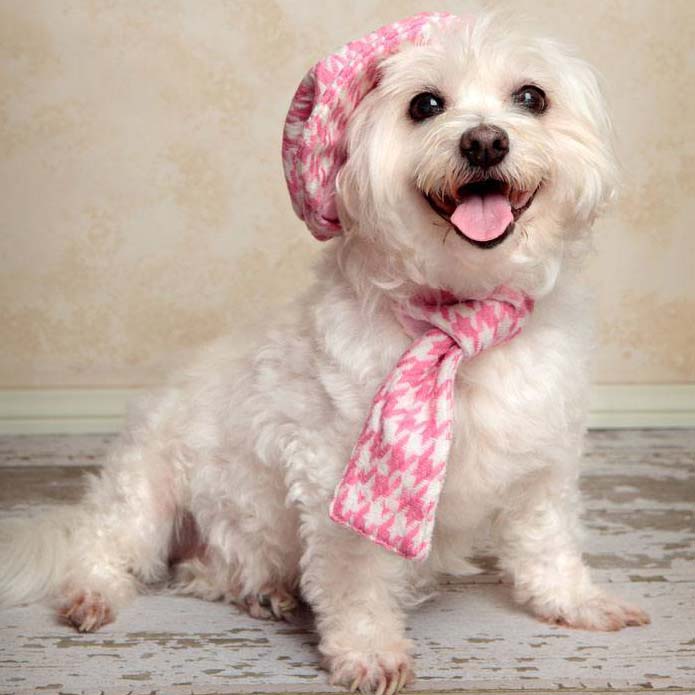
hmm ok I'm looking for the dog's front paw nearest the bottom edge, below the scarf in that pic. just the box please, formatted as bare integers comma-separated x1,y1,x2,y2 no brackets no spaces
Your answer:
324,646,415,695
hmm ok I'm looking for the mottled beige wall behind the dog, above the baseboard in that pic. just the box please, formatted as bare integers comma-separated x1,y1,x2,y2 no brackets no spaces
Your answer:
0,0,695,388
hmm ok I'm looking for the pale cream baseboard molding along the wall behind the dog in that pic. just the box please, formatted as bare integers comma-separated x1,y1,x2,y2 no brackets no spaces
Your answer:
0,384,695,434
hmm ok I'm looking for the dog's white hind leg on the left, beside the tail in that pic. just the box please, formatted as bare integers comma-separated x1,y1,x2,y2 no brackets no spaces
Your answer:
54,443,182,632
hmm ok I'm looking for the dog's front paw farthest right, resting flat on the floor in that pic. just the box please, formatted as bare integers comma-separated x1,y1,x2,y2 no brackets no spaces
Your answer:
541,594,651,632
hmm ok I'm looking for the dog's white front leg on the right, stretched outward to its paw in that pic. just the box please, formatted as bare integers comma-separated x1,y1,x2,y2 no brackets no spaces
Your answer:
496,479,649,630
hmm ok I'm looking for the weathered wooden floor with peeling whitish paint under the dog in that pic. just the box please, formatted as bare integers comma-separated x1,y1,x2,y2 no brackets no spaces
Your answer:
0,430,695,695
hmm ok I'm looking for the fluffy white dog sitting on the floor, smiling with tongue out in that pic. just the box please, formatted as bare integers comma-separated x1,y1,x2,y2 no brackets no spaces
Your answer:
0,15,648,694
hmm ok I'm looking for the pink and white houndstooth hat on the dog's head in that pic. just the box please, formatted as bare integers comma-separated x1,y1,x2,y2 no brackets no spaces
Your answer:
282,12,459,241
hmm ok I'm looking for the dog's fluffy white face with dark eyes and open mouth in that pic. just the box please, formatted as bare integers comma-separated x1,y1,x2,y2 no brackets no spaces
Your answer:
338,18,615,296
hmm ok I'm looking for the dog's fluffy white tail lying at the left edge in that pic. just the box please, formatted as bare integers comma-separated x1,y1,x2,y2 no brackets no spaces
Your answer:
0,508,80,607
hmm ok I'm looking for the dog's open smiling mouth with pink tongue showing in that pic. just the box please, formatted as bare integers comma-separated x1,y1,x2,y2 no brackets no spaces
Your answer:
424,179,540,249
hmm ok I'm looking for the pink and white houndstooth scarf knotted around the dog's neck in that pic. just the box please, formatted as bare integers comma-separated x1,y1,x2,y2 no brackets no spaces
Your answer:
330,288,533,560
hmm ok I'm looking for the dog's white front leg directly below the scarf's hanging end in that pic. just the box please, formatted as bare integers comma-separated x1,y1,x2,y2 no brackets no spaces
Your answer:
302,519,413,695
